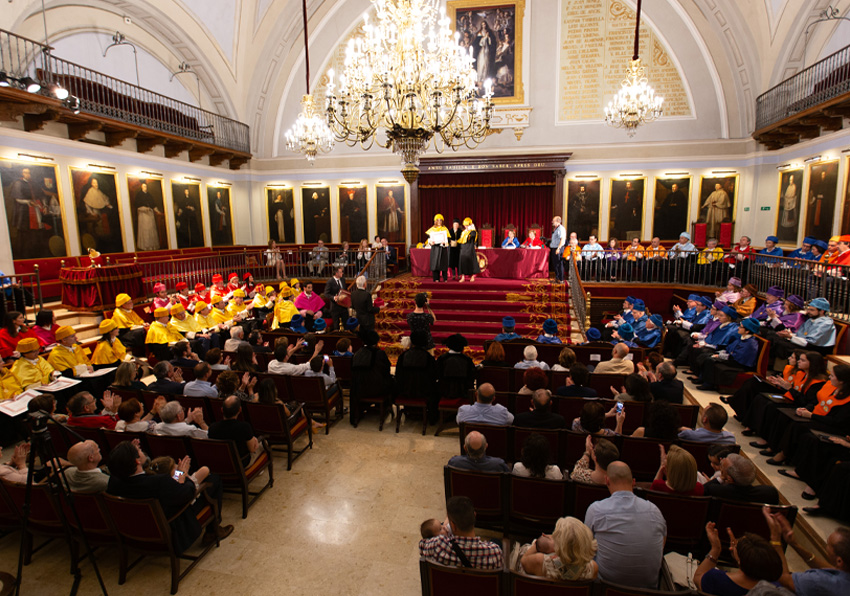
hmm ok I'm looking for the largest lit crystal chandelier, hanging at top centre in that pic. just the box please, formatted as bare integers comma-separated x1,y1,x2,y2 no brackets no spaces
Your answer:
327,0,493,182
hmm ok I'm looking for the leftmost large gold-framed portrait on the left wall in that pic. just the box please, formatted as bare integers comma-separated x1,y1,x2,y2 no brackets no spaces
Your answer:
0,157,70,260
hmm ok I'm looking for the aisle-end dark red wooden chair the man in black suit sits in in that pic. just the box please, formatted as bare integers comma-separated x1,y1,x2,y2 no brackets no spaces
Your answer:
101,494,219,594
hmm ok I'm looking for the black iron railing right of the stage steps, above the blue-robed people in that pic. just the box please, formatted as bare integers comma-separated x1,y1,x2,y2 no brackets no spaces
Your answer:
568,250,850,322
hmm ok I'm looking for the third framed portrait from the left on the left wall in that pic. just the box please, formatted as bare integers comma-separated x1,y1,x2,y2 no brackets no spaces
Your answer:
127,174,171,252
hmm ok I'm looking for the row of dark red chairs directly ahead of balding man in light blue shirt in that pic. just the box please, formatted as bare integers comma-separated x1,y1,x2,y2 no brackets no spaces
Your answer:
443,466,797,555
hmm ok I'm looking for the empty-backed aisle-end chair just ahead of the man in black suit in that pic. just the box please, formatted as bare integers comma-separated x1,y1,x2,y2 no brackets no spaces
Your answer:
189,439,274,519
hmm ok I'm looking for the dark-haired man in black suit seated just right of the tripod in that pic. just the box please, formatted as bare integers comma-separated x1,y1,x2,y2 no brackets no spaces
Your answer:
106,441,233,553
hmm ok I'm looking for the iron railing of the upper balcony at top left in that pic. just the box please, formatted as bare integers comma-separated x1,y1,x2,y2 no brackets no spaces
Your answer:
0,29,250,153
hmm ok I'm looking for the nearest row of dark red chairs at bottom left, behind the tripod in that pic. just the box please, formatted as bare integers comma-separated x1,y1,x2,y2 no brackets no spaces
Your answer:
0,480,219,594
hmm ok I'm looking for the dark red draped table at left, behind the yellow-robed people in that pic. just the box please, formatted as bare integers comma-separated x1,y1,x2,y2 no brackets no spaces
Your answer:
59,263,144,311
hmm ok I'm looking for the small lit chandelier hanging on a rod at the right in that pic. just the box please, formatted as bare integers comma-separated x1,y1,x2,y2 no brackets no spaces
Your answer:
605,0,664,137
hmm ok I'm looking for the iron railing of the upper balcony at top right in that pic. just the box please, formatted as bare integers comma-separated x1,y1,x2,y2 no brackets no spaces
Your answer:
756,46,850,130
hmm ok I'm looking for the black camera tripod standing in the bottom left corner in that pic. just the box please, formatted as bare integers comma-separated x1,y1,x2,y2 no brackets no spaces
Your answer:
15,410,109,596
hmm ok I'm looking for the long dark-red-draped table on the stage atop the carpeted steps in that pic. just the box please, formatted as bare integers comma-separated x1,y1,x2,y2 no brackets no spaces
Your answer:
410,248,549,279
